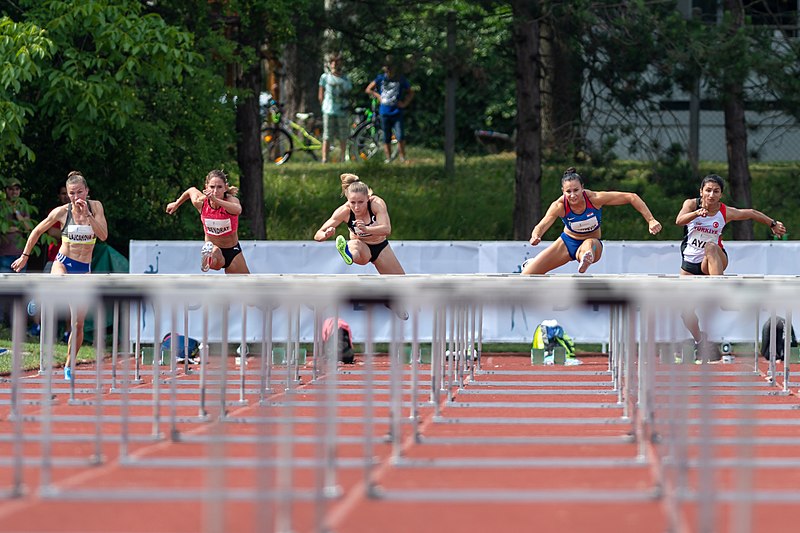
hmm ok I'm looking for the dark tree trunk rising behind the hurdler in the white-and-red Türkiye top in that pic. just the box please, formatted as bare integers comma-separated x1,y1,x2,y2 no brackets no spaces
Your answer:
723,0,753,241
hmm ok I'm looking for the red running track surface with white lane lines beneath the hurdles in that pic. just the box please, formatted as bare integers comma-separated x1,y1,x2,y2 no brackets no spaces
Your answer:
0,356,800,533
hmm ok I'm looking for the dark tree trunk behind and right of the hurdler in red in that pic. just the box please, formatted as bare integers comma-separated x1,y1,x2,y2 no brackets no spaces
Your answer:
236,63,267,240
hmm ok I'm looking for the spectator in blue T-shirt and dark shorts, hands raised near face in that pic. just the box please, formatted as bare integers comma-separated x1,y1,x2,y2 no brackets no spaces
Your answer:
364,58,414,163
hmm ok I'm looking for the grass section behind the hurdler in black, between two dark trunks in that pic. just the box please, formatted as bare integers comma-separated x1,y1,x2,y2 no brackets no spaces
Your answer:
265,150,514,240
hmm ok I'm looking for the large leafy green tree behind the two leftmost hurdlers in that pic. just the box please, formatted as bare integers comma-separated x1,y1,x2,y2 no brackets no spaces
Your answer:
0,0,223,250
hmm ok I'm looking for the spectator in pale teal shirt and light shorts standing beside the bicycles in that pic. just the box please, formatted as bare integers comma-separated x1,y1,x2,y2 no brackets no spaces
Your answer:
319,55,353,163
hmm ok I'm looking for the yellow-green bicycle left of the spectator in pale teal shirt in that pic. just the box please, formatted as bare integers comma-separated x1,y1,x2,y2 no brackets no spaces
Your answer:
261,97,322,165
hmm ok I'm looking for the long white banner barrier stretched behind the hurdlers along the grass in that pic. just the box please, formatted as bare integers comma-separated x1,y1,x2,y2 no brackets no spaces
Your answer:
129,241,800,343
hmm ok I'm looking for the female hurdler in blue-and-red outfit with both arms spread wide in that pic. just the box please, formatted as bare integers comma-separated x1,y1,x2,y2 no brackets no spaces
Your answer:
522,167,661,274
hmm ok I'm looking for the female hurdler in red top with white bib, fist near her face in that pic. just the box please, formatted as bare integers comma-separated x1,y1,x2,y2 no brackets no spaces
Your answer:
167,170,250,274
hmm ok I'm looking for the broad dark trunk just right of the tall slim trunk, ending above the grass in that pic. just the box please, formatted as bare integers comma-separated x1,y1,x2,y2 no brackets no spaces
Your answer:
539,10,582,158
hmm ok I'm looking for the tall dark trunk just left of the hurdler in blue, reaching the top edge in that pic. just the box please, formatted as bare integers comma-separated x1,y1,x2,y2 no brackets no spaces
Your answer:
511,0,542,240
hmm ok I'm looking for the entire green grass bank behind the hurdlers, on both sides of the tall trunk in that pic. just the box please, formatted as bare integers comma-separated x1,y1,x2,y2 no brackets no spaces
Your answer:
265,147,800,241
